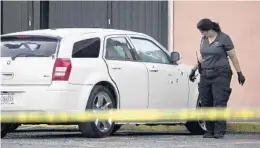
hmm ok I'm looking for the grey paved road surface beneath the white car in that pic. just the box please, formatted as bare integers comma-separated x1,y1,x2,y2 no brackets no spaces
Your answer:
1,130,260,148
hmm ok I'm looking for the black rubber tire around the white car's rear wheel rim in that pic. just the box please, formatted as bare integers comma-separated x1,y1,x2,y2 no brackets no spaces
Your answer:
79,85,116,138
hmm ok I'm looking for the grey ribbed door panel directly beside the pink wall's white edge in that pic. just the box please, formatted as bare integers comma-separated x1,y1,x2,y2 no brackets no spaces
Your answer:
111,1,168,47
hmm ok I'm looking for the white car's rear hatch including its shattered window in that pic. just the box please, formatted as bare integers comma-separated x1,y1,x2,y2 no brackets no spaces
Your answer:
0,36,59,85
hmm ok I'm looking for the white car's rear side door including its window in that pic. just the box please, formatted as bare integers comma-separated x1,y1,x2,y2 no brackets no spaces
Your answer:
104,35,149,109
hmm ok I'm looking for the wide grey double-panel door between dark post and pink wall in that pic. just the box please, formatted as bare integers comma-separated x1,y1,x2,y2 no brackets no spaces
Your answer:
49,1,168,47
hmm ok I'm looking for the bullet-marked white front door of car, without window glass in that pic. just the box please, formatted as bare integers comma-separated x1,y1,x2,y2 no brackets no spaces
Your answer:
128,35,189,109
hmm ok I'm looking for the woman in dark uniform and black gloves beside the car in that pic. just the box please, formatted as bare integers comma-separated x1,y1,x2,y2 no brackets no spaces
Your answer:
189,18,245,138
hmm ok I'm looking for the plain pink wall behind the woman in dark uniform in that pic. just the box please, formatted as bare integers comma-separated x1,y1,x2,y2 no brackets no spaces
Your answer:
173,1,260,108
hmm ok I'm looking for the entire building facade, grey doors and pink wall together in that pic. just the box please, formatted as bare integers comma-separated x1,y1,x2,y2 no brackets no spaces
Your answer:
1,1,260,108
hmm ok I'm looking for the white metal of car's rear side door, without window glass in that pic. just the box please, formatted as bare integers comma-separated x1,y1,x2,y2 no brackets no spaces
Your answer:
103,35,149,109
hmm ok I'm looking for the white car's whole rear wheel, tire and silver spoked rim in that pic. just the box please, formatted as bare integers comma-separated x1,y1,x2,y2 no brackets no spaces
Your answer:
79,85,116,138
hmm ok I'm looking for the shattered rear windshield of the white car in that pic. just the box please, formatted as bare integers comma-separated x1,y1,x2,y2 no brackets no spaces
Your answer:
1,36,59,57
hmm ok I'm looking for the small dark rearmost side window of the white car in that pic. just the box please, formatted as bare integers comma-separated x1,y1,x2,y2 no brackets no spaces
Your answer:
72,38,100,58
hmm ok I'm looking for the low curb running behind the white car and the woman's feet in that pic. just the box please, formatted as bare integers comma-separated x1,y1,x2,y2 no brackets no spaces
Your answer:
19,122,260,133
